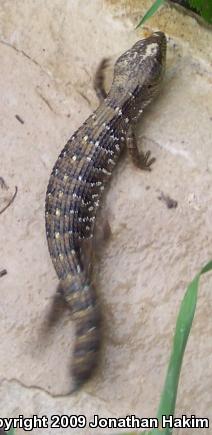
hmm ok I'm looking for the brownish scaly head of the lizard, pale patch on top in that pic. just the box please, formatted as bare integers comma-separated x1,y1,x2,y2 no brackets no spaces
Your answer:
111,32,166,109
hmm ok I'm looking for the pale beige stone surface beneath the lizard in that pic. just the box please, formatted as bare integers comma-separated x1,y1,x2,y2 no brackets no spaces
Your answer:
0,0,212,435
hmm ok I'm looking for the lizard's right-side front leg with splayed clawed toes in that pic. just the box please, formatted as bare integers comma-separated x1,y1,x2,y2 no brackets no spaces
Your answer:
126,127,155,171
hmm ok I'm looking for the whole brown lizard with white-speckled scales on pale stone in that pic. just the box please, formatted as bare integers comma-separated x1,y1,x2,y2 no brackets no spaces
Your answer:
45,31,166,388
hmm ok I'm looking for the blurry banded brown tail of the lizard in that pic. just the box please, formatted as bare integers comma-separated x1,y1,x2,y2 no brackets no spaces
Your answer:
58,275,101,389
